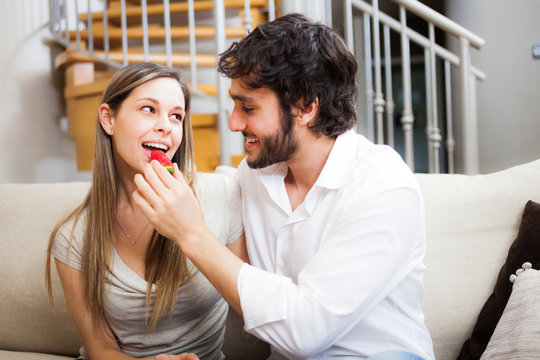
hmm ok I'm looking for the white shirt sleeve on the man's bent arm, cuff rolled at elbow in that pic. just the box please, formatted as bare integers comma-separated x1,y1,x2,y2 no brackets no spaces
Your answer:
238,187,425,358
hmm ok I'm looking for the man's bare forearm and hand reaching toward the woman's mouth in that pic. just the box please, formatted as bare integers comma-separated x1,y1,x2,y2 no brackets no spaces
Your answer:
133,161,245,314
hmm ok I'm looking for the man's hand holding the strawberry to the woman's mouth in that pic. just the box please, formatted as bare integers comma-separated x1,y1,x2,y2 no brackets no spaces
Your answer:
132,160,206,247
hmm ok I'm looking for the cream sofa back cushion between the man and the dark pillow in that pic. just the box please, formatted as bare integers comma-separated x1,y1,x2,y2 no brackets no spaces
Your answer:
416,160,540,360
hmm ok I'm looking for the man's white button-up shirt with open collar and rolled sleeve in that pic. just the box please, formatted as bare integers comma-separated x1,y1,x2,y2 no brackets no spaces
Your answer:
238,130,434,359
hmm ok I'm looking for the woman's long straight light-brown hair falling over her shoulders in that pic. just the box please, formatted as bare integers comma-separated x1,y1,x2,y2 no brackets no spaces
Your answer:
45,63,195,330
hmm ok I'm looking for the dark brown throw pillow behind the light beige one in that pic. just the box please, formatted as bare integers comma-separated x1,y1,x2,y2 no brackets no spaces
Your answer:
458,201,540,360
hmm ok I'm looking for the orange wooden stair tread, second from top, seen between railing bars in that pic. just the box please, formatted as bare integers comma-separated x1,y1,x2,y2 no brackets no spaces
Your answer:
70,22,245,41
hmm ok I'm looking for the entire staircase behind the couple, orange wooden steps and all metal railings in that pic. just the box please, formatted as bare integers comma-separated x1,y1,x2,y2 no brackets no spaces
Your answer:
50,0,486,173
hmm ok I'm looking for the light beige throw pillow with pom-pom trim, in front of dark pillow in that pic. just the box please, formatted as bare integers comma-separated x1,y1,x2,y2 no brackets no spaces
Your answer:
480,269,540,360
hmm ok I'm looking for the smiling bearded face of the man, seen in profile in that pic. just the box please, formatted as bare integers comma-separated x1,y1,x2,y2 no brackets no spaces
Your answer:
229,79,297,168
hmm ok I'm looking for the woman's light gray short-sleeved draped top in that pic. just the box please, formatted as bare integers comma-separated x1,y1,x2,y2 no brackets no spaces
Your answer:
52,174,243,360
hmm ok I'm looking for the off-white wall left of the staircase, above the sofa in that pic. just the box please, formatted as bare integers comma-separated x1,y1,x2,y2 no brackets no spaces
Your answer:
0,0,90,183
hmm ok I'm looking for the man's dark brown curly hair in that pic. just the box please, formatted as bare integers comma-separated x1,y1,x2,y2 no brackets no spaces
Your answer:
218,14,358,136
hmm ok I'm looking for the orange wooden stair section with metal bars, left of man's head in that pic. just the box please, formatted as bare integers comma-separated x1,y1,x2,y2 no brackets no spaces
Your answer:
50,0,275,172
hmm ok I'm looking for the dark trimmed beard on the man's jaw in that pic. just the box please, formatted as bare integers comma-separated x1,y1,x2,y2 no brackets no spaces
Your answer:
244,127,298,169
